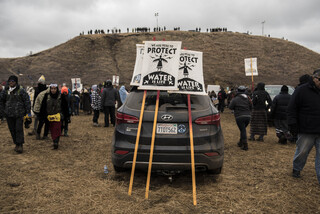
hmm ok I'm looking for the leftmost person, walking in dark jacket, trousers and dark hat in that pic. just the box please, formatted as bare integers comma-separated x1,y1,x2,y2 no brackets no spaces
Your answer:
0,75,31,153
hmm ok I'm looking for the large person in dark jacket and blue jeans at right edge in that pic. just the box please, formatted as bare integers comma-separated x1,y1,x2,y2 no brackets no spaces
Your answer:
287,68,320,184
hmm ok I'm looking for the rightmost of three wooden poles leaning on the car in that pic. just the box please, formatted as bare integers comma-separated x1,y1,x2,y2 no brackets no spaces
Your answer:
188,94,197,206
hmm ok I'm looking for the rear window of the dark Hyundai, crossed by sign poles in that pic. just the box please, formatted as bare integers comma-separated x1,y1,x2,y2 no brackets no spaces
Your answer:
126,90,210,111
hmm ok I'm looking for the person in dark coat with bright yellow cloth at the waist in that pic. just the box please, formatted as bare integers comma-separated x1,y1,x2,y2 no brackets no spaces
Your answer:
34,84,70,149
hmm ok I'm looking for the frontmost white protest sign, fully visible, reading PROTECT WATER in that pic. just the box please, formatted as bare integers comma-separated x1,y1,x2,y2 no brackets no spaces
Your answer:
139,41,181,90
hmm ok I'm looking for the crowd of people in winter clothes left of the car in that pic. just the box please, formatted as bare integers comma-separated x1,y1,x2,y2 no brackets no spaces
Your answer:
0,75,128,150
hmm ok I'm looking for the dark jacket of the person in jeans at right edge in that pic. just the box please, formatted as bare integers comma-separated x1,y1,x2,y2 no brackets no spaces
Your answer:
288,80,320,134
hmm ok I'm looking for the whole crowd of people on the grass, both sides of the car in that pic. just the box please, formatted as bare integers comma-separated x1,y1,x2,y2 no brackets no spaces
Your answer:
0,69,320,184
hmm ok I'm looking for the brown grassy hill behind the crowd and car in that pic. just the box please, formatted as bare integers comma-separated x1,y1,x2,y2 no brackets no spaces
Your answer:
0,31,320,86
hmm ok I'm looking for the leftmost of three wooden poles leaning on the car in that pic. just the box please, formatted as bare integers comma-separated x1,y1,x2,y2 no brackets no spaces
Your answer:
128,90,147,195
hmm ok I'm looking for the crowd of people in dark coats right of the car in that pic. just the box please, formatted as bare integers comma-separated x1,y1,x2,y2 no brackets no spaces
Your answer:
210,69,320,184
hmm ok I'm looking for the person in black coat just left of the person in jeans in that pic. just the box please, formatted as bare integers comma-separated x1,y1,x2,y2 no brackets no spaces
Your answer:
271,85,292,144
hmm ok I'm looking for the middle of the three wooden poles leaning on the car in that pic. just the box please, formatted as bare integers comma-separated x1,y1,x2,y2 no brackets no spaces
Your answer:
145,90,160,199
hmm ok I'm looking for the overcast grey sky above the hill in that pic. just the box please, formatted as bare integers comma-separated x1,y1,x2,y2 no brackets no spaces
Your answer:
0,0,320,58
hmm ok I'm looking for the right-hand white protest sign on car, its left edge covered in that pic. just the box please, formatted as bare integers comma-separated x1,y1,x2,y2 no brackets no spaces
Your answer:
170,50,207,95
